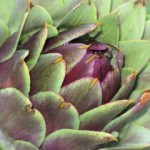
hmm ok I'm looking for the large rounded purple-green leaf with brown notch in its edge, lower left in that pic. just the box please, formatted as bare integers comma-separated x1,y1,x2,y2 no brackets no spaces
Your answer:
0,88,46,147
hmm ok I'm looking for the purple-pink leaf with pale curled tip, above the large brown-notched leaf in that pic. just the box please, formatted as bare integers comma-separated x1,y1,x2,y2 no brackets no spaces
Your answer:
0,51,30,95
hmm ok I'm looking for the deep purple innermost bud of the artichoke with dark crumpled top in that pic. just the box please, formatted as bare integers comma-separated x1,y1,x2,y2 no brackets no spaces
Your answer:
64,43,113,85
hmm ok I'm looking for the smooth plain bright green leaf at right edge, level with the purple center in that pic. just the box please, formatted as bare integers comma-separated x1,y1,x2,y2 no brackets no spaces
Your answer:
119,40,150,72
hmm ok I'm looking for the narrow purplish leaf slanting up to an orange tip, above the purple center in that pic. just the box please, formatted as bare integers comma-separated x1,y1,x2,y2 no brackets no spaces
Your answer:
45,24,97,51
